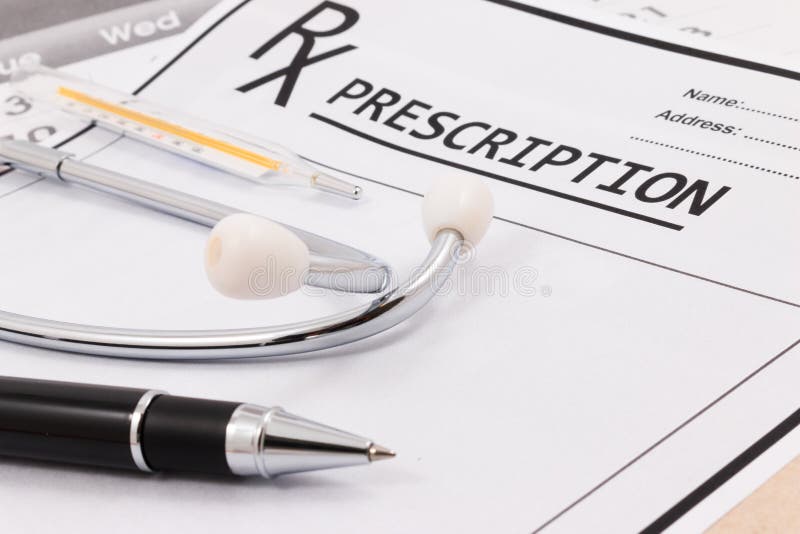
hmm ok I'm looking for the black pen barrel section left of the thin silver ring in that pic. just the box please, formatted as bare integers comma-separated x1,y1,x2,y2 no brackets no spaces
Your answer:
0,377,147,469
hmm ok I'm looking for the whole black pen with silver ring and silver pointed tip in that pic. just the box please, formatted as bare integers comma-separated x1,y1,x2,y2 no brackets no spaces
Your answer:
0,377,394,478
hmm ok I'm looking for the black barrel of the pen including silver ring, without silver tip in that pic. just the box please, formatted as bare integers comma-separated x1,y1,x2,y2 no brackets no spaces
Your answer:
0,377,240,475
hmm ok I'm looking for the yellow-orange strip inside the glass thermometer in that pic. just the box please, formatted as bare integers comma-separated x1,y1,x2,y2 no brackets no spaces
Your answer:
58,87,281,171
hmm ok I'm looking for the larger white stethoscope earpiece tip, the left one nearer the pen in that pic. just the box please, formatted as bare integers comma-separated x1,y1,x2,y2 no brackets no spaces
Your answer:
205,213,309,299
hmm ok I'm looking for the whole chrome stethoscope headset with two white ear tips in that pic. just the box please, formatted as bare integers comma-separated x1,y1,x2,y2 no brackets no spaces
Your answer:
0,141,493,360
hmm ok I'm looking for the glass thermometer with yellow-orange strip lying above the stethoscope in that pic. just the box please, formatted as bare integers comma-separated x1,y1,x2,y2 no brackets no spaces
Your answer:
11,64,361,199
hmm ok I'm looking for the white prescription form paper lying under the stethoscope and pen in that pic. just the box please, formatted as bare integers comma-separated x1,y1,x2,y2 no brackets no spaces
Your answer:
0,0,800,532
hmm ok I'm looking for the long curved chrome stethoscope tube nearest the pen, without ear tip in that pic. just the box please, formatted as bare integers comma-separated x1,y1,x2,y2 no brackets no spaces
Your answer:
0,230,463,360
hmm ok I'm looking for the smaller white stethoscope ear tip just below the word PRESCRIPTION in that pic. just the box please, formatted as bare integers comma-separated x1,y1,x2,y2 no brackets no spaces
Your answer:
422,174,494,245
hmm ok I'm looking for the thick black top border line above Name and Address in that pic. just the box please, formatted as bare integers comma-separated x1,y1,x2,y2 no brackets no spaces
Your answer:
485,0,800,81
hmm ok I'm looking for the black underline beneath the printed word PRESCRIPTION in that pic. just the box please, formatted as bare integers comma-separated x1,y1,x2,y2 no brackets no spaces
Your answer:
309,112,683,231
